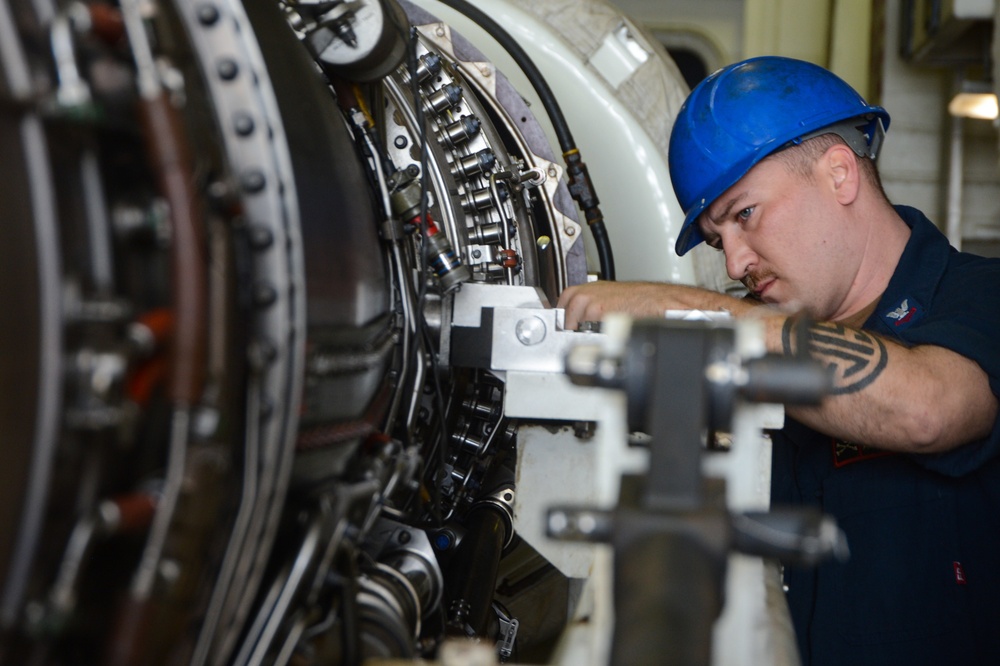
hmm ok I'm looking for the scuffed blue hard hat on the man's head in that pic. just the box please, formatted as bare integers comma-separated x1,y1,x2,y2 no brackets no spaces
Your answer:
668,56,889,255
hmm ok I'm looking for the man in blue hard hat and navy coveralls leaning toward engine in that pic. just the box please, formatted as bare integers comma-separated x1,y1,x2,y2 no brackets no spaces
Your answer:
559,57,1000,666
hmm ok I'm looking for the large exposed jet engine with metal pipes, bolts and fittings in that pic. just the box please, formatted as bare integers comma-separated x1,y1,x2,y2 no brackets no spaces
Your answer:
0,0,808,666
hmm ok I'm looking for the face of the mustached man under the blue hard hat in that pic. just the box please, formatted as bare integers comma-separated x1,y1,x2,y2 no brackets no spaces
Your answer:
698,154,860,319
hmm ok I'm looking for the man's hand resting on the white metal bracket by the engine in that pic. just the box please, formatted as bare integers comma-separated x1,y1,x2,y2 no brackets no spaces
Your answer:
556,281,753,331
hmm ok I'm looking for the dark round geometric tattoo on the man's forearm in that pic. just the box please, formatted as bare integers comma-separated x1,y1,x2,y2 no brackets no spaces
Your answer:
781,317,889,395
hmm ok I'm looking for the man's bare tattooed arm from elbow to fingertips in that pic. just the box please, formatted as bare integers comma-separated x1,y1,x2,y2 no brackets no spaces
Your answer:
558,274,1000,453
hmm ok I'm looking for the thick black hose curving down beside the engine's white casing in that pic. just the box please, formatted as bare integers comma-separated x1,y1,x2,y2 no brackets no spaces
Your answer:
438,0,615,280
